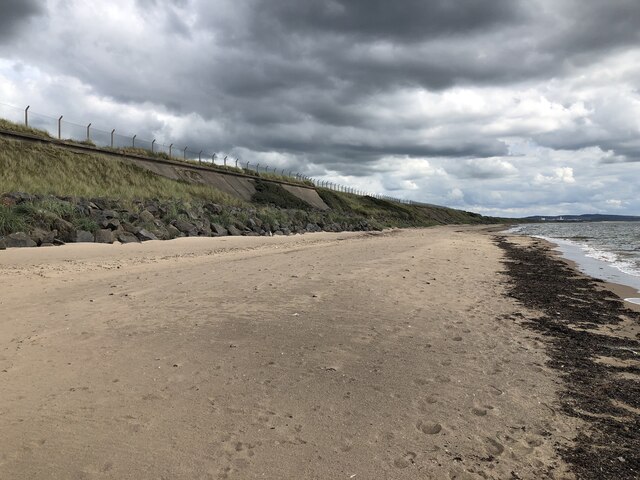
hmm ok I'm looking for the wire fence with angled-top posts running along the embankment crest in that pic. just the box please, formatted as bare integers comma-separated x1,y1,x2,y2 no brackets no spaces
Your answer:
0,102,420,205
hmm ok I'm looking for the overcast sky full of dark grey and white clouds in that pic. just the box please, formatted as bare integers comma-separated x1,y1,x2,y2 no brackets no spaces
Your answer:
0,0,640,216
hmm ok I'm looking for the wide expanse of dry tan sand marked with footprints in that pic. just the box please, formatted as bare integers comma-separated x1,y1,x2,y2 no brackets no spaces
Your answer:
0,227,578,480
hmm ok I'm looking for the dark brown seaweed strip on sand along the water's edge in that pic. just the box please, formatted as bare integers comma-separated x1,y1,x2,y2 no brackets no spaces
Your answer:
495,236,640,480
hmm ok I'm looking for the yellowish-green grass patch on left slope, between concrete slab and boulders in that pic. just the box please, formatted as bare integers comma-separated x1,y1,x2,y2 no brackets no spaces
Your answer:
0,138,246,206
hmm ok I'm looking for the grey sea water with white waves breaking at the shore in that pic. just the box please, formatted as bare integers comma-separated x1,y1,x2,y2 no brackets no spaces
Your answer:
509,222,640,304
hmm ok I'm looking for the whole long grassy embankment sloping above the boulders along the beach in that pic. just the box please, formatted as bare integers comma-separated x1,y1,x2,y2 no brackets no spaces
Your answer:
0,130,500,235
